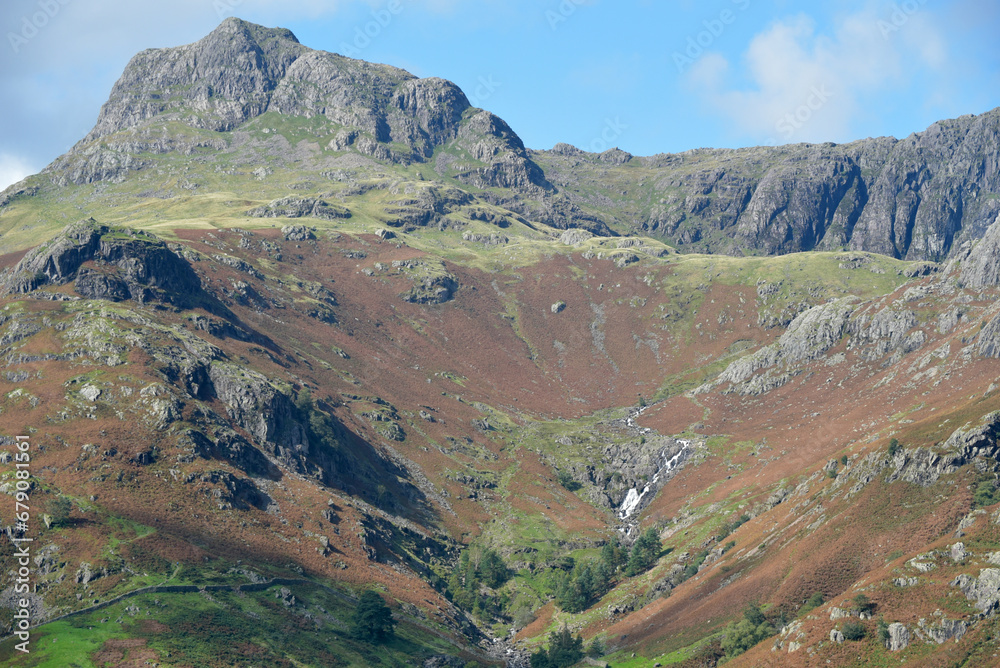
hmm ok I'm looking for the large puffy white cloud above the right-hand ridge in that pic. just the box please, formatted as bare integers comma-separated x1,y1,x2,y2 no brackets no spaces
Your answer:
685,10,948,143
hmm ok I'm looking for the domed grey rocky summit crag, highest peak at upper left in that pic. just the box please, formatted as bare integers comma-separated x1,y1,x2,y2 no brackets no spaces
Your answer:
45,18,551,193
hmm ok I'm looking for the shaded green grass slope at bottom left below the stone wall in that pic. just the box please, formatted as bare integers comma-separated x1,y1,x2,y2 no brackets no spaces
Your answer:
0,586,470,668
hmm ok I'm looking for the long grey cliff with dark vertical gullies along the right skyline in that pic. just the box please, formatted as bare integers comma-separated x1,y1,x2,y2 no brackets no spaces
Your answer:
536,110,1000,261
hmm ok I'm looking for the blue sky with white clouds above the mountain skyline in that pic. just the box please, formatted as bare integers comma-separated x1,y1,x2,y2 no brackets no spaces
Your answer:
0,0,1000,188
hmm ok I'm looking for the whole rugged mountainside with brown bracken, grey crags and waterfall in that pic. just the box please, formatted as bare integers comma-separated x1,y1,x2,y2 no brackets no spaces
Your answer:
0,19,1000,667
